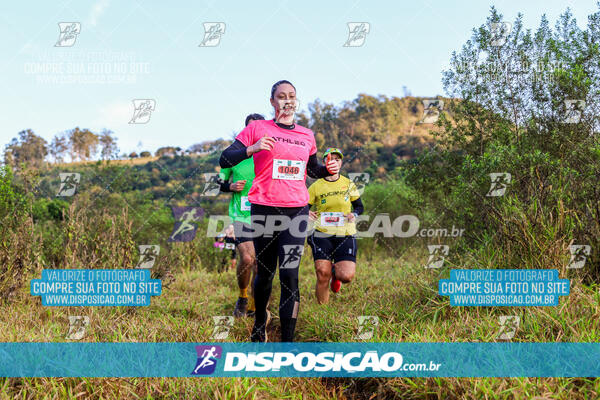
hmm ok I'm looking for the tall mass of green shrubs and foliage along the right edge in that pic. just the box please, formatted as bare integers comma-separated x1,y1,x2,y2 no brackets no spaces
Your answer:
403,8,600,272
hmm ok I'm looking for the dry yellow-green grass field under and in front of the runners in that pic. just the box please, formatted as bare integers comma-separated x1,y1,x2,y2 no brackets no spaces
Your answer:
0,245,600,399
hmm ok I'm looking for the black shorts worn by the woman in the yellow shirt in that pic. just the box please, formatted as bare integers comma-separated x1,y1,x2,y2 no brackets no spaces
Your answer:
308,230,357,263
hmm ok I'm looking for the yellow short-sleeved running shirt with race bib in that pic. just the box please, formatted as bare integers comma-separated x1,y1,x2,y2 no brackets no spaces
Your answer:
308,175,360,236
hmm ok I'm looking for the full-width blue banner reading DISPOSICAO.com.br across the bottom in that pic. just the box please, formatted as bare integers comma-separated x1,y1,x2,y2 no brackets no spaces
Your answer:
0,342,600,377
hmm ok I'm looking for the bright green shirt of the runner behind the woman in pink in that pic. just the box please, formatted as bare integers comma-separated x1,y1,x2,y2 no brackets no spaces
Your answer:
219,157,254,224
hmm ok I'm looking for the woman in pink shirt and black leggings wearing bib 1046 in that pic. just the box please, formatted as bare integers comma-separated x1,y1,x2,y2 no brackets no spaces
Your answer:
219,80,339,342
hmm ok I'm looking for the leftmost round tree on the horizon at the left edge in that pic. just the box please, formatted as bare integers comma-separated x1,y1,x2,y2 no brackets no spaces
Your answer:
4,129,48,168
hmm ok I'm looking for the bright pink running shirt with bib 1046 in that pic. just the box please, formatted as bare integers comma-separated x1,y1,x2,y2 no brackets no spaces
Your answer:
236,120,317,207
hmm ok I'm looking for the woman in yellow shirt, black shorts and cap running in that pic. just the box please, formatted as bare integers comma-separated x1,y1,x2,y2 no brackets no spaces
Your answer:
308,148,363,304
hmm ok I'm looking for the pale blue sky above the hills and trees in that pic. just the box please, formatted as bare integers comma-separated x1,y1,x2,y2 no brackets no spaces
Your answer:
0,0,599,156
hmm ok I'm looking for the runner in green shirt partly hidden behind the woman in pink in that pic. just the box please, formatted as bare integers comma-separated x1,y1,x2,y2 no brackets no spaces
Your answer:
219,114,265,317
